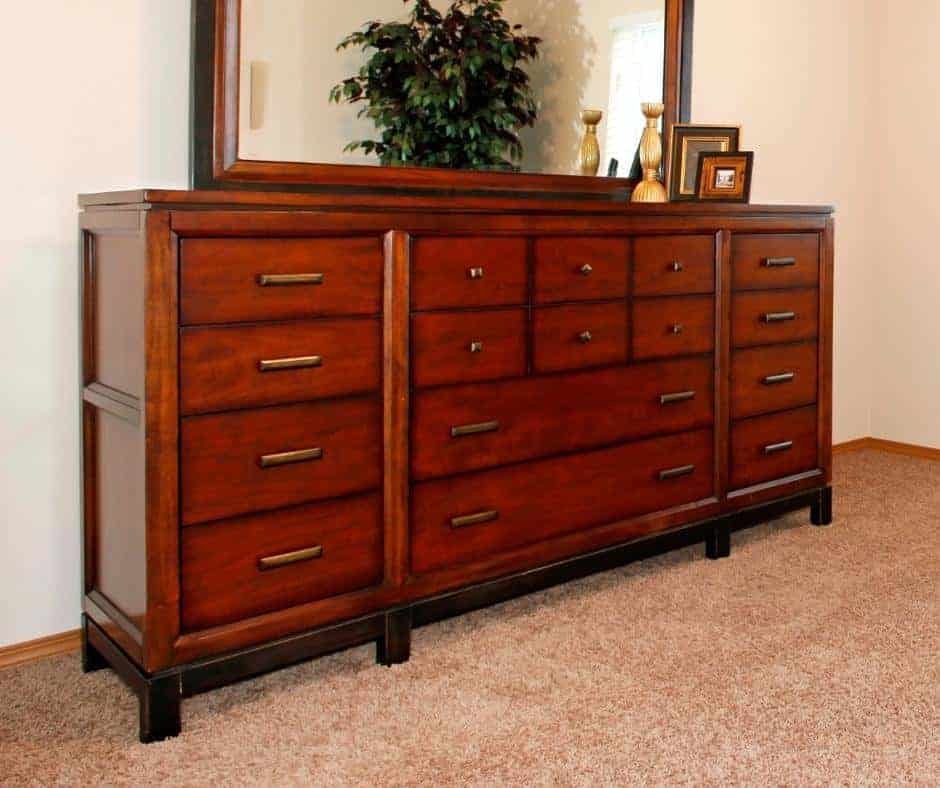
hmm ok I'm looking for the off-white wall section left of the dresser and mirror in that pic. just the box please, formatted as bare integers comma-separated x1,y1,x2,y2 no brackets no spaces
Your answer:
0,0,189,646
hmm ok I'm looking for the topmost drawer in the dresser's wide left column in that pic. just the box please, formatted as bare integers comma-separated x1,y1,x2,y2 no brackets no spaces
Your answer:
180,237,383,324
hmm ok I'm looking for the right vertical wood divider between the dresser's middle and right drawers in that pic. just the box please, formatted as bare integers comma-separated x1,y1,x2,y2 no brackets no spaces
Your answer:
715,230,732,502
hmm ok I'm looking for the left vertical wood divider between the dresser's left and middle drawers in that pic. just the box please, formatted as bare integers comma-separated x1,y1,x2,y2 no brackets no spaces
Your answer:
382,230,411,586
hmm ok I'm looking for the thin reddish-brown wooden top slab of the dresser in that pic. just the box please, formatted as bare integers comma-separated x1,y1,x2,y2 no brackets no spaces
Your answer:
78,189,834,217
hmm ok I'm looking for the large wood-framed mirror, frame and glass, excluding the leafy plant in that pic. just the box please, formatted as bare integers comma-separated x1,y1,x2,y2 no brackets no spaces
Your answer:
193,0,693,196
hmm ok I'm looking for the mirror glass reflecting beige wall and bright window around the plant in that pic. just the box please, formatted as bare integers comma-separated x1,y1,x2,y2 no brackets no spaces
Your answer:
239,0,666,177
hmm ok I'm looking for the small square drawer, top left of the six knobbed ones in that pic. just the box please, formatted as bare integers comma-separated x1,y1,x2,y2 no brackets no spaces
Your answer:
411,238,529,310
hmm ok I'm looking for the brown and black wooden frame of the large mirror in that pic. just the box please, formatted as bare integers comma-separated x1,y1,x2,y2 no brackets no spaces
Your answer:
190,0,695,199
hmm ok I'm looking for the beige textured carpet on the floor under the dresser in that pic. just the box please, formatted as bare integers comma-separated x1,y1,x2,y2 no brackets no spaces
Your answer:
0,452,940,786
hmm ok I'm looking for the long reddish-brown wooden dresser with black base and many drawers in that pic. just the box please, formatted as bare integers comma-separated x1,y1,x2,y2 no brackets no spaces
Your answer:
81,191,833,741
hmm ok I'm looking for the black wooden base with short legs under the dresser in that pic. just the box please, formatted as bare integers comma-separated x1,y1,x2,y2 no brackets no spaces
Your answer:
82,487,832,743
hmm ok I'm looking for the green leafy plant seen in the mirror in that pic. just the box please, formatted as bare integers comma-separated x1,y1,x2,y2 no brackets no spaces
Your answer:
330,0,541,169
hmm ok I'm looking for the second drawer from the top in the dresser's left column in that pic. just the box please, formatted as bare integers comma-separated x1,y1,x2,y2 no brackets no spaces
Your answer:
180,319,381,415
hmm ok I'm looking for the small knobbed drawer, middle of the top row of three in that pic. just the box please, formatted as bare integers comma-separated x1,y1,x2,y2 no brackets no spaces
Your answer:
535,238,629,304
